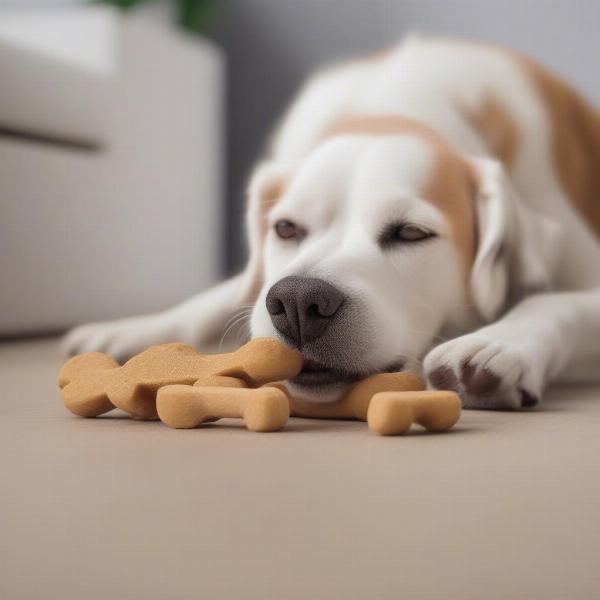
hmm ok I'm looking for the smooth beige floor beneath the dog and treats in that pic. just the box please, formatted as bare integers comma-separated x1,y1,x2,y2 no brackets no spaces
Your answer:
0,340,600,600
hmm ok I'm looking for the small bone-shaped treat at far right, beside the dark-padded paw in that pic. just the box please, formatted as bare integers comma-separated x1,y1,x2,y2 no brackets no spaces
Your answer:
367,391,461,435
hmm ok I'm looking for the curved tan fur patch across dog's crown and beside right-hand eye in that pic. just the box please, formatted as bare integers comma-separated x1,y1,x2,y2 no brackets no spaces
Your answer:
324,115,477,276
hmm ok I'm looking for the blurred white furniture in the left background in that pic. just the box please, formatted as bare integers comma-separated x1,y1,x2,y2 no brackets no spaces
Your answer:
0,6,223,334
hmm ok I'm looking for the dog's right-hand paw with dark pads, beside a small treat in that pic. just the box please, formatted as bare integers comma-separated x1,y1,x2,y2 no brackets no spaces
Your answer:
424,334,543,410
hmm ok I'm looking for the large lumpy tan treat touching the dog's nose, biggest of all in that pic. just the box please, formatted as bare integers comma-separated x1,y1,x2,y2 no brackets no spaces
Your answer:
59,338,302,419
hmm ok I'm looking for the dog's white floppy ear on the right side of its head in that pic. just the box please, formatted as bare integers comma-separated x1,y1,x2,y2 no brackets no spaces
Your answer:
471,158,560,321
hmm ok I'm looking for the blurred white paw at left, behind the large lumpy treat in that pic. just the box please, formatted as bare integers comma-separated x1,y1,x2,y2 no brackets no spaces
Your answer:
62,316,180,362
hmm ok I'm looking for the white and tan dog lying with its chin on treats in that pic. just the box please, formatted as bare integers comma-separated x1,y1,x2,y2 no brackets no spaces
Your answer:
66,37,600,408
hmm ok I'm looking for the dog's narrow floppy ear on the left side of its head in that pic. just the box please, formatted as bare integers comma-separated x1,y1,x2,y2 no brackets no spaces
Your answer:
238,161,293,302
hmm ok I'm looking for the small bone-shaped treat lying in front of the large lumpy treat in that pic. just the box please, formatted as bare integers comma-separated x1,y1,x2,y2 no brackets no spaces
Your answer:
156,385,290,431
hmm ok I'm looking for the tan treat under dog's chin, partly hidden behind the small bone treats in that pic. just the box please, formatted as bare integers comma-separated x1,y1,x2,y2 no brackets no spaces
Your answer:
284,371,425,421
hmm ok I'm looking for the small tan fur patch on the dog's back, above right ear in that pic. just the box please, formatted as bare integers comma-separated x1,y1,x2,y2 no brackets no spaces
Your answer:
462,93,520,169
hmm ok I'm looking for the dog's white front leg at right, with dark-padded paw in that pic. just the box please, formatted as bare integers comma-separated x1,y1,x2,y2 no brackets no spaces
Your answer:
424,289,600,409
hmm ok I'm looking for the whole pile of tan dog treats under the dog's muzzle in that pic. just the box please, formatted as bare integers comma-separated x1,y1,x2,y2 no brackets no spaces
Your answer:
59,338,461,435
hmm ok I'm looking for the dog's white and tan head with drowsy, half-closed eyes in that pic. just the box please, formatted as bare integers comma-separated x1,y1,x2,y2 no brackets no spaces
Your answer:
237,120,551,401
